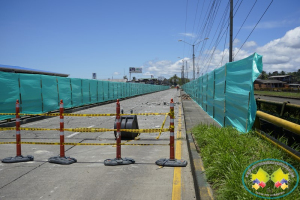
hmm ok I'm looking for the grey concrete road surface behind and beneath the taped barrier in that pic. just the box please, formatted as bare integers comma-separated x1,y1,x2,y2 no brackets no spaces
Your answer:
0,89,195,200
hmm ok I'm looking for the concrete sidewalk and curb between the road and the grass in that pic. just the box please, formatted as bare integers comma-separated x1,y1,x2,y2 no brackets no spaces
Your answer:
180,91,220,200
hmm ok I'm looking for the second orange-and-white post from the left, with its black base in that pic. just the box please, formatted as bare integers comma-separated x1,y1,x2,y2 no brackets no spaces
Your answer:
48,100,77,165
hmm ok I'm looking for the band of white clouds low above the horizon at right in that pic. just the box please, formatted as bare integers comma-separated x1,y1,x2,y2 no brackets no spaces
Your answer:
143,27,300,78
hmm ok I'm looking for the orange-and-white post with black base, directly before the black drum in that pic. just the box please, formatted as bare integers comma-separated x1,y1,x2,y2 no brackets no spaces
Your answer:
104,99,135,166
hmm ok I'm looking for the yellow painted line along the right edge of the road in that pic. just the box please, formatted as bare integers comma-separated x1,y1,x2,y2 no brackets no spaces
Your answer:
172,101,182,200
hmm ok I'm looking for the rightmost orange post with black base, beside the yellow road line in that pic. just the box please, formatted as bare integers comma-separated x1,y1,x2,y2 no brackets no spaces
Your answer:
155,99,187,167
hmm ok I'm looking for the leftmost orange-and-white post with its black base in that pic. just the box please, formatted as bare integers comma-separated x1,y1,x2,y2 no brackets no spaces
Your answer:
2,100,34,163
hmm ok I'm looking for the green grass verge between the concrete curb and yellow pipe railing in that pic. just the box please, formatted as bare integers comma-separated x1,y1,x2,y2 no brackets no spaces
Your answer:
193,125,300,200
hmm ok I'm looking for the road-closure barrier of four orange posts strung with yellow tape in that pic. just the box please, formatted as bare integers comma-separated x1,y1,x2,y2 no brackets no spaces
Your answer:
0,99,187,167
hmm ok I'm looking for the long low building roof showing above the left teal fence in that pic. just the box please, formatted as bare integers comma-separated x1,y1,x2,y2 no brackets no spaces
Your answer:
0,65,69,77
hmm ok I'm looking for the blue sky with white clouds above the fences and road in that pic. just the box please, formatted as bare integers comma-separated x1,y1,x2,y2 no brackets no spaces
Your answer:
0,0,300,79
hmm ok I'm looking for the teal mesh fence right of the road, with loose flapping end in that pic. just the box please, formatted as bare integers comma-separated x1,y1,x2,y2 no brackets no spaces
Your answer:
183,53,263,133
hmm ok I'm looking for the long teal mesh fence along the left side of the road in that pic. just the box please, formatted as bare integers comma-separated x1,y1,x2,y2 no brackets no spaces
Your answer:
0,72,169,120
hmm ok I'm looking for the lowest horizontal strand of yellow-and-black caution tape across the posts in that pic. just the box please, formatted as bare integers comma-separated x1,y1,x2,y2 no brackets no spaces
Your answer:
0,142,169,146
